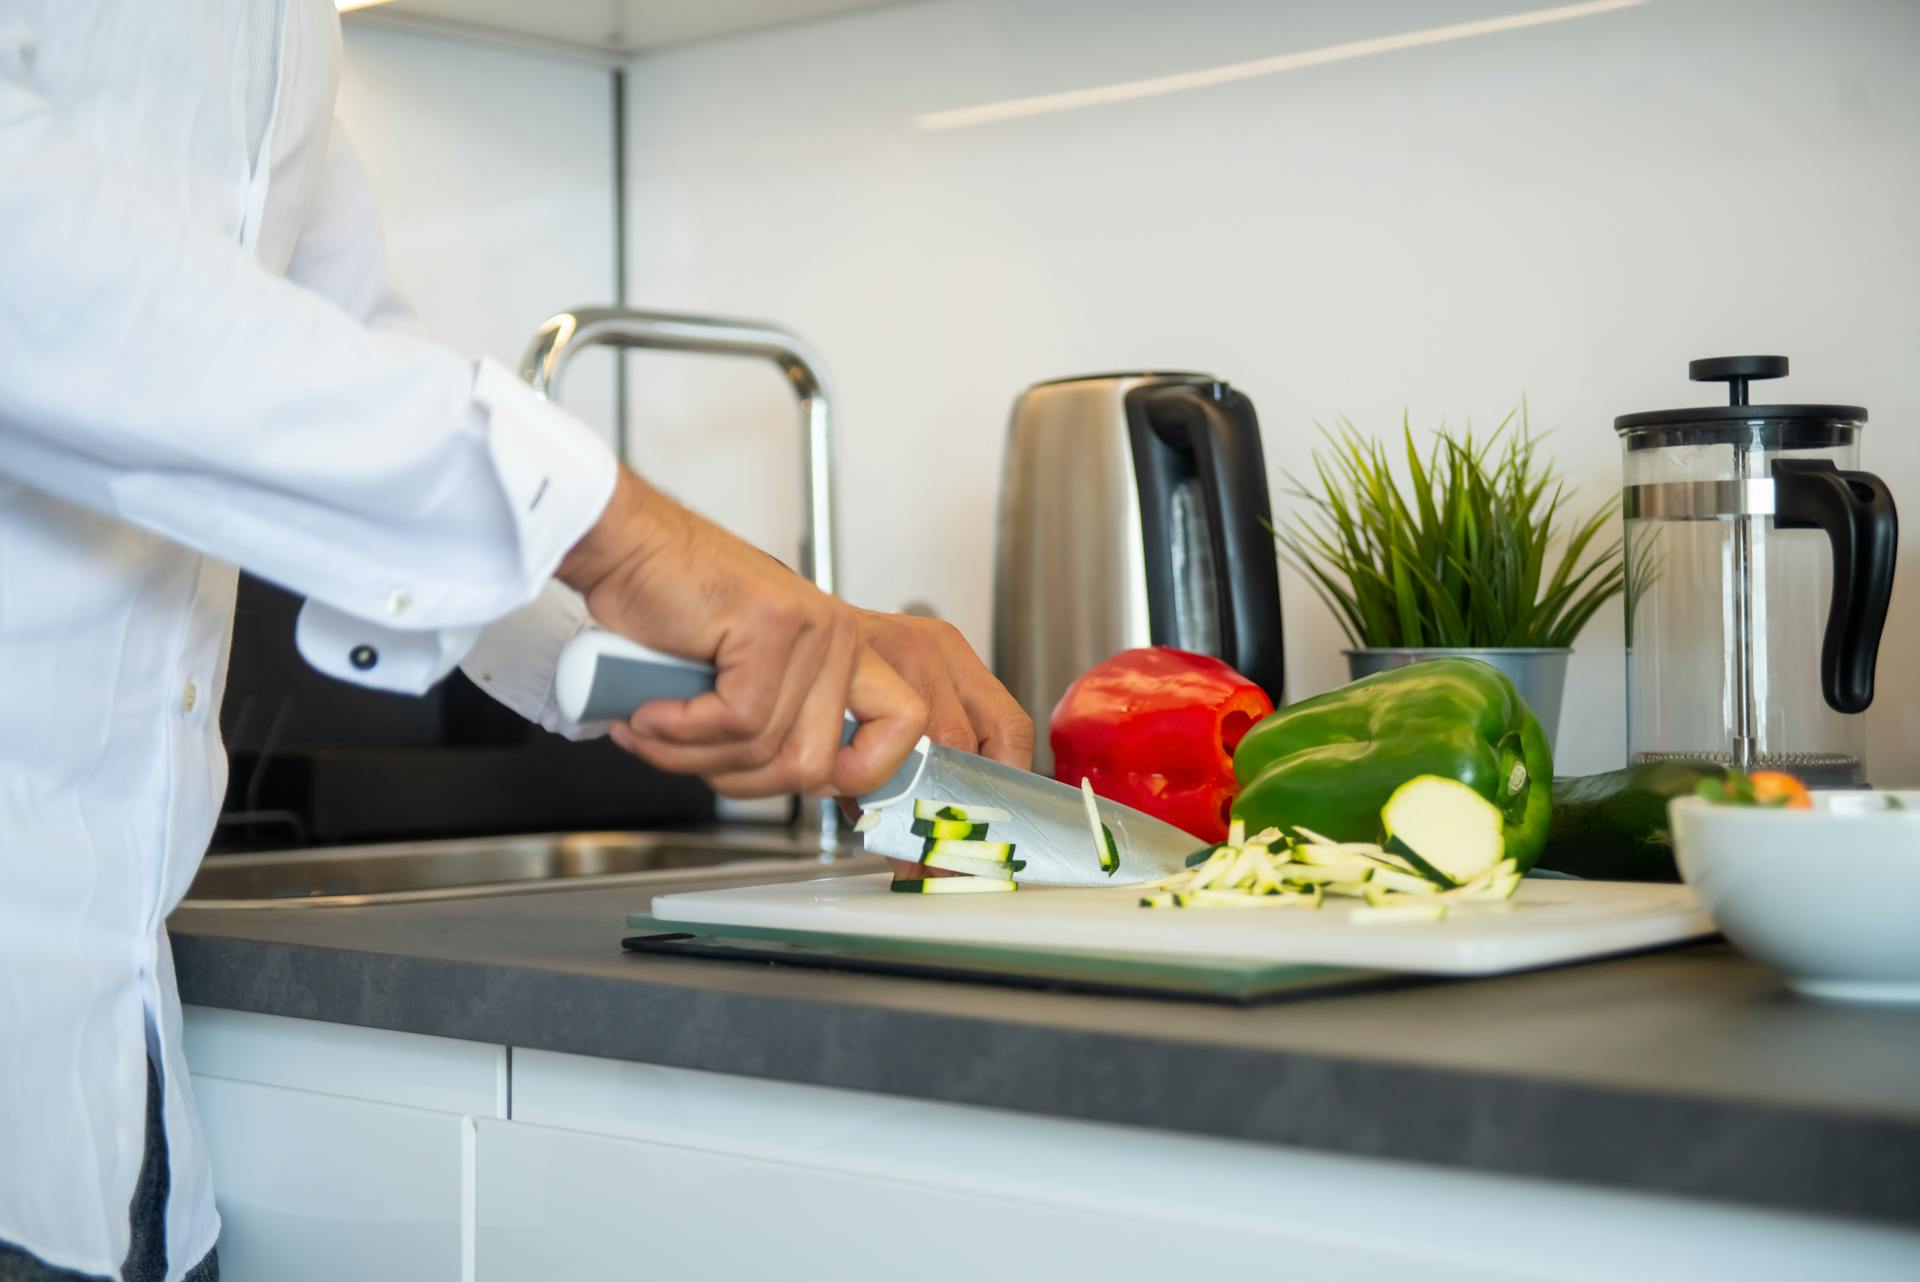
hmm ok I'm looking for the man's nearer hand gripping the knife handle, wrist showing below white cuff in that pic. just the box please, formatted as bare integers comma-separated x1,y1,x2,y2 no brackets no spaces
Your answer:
559,468,929,796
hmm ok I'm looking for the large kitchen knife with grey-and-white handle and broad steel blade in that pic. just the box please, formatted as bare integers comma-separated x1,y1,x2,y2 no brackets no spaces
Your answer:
553,631,1202,887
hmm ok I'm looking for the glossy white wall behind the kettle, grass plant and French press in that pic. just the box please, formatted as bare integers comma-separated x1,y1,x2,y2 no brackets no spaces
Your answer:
614,0,1920,783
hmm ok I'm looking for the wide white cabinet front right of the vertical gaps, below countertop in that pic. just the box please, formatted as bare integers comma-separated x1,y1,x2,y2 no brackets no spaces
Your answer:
506,1052,1920,1282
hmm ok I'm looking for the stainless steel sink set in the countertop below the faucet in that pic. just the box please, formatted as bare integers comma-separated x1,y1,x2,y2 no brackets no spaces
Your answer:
180,831,854,908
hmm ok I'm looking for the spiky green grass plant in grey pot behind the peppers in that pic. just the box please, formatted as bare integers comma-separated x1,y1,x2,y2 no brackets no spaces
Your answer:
1275,403,1624,741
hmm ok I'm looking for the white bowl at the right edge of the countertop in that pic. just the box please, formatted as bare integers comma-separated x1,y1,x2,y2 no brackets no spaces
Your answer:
1667,793,1920,1002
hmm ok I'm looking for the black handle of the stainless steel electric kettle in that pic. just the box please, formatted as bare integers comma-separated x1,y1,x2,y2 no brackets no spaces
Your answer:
1127,382,1286,706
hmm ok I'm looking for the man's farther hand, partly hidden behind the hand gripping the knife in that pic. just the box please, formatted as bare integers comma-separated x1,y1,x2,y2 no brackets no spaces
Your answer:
858,610,1033,770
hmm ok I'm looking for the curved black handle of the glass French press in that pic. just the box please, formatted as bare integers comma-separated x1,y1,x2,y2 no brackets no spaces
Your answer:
1772,459,1901,712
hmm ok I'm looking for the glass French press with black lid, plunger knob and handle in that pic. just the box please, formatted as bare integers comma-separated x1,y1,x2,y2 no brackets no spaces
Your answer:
1613,357,1899,787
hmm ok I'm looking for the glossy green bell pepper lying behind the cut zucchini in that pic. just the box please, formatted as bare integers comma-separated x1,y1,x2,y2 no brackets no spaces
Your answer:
1233,658,1553,871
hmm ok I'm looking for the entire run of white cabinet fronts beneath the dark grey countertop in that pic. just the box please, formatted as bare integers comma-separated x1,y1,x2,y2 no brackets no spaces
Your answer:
186,1008,1920,1282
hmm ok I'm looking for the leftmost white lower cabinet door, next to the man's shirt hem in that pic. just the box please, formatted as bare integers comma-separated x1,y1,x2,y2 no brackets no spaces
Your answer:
194,1077,472,1282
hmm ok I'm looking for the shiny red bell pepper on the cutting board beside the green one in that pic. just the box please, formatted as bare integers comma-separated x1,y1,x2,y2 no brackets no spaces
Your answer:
1048,645,1273,841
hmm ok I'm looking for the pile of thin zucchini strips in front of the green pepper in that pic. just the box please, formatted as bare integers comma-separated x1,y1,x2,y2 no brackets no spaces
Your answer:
1140,819,1521,925
